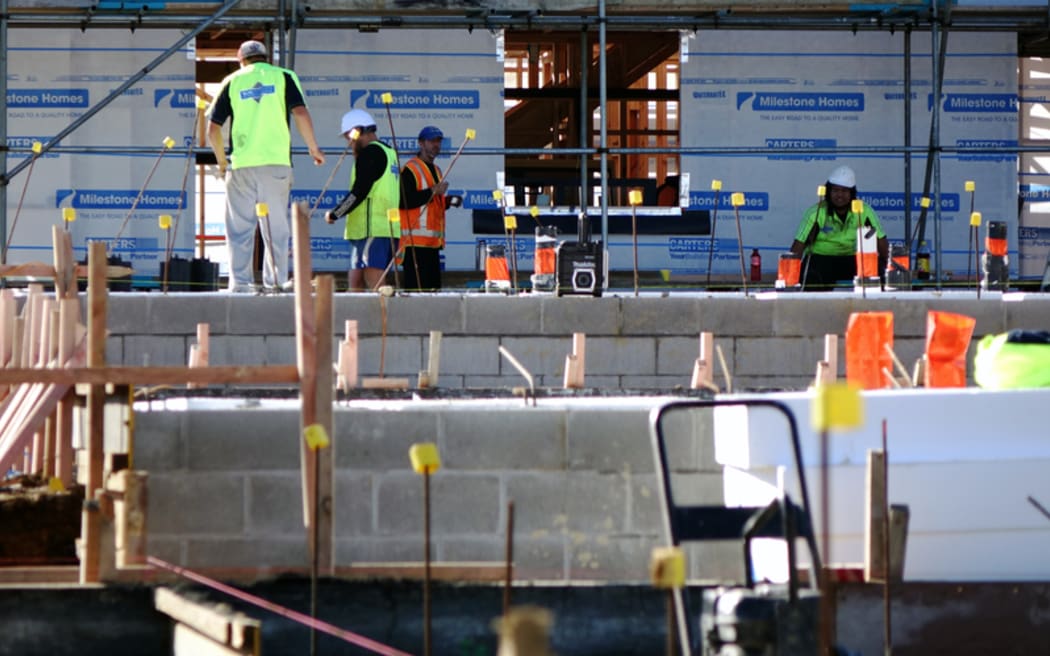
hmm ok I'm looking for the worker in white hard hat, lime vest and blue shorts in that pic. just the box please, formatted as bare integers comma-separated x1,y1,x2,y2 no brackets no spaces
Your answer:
324,109,401,292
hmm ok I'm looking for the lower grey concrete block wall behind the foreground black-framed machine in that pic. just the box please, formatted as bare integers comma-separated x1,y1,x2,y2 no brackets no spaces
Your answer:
134,397,742,581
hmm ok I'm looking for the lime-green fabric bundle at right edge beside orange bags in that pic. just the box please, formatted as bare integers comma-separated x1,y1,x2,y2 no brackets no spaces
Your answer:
973,333,1050,389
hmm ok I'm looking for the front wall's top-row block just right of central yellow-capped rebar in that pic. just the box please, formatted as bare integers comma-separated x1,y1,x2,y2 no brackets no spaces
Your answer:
441,407,566,470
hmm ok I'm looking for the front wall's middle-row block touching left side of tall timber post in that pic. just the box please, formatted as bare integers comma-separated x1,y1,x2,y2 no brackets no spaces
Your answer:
245,469,303,539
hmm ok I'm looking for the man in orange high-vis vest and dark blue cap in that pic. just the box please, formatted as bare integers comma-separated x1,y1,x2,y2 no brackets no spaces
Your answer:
401,125,460,291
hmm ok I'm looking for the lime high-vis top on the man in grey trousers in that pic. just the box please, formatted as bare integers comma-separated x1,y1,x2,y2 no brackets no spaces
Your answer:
224,62,301,169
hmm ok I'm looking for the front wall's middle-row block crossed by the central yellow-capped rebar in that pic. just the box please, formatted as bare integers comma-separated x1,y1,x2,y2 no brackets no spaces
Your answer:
375,471,501,536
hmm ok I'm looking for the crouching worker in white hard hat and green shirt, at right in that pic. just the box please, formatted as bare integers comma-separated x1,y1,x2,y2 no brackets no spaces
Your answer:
791,166,889,291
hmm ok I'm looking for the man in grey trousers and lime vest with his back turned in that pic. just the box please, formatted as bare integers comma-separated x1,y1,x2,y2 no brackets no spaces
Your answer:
208,41,324,293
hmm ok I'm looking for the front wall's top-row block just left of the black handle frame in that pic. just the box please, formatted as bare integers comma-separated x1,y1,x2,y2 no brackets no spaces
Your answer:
568,408,653,473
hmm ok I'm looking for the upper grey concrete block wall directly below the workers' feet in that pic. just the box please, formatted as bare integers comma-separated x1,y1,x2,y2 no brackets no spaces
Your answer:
107,292,1050,390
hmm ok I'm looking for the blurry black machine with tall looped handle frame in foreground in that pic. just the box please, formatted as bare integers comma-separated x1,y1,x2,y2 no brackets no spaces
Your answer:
651,400,820,656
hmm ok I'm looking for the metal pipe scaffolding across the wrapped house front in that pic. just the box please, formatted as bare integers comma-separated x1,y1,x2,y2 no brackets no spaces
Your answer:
0,0,1050,282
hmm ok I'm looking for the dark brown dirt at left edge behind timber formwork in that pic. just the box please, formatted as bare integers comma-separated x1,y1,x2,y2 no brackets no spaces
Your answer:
0,475,84,567
